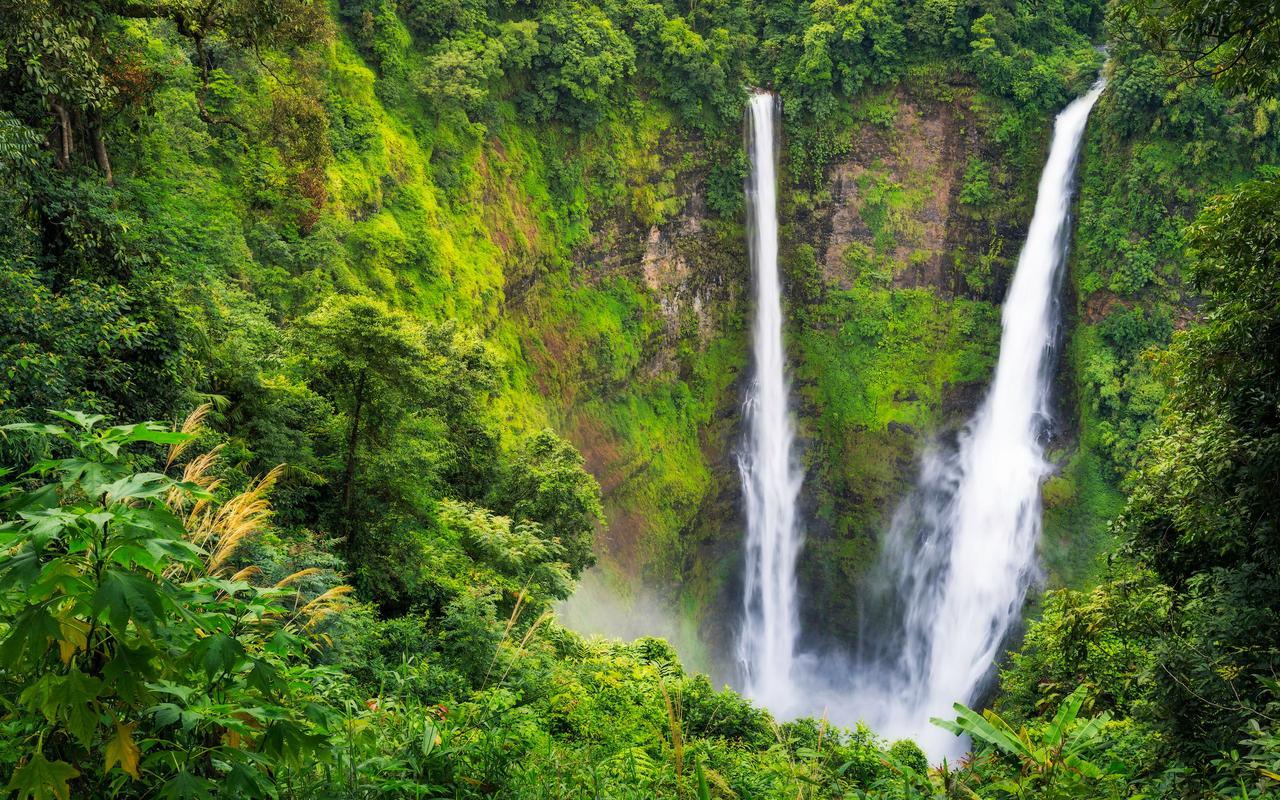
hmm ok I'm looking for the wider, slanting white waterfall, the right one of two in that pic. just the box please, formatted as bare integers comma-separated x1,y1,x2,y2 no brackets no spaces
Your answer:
852,79,1103,756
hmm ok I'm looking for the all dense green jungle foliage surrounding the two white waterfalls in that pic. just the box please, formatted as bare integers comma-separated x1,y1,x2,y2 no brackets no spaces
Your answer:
0,0,1280,800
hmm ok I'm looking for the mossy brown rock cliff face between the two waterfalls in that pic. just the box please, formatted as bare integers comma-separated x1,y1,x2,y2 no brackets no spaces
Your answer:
788,82,1048,650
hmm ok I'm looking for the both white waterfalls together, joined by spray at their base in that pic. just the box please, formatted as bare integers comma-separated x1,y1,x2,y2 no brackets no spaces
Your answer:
739,79,1103,758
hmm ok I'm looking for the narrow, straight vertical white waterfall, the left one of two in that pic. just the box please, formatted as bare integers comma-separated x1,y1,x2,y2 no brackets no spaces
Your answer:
739,92,801,714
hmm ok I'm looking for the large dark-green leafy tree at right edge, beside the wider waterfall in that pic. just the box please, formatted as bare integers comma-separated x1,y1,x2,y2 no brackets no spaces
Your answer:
1125,179,1280,586
